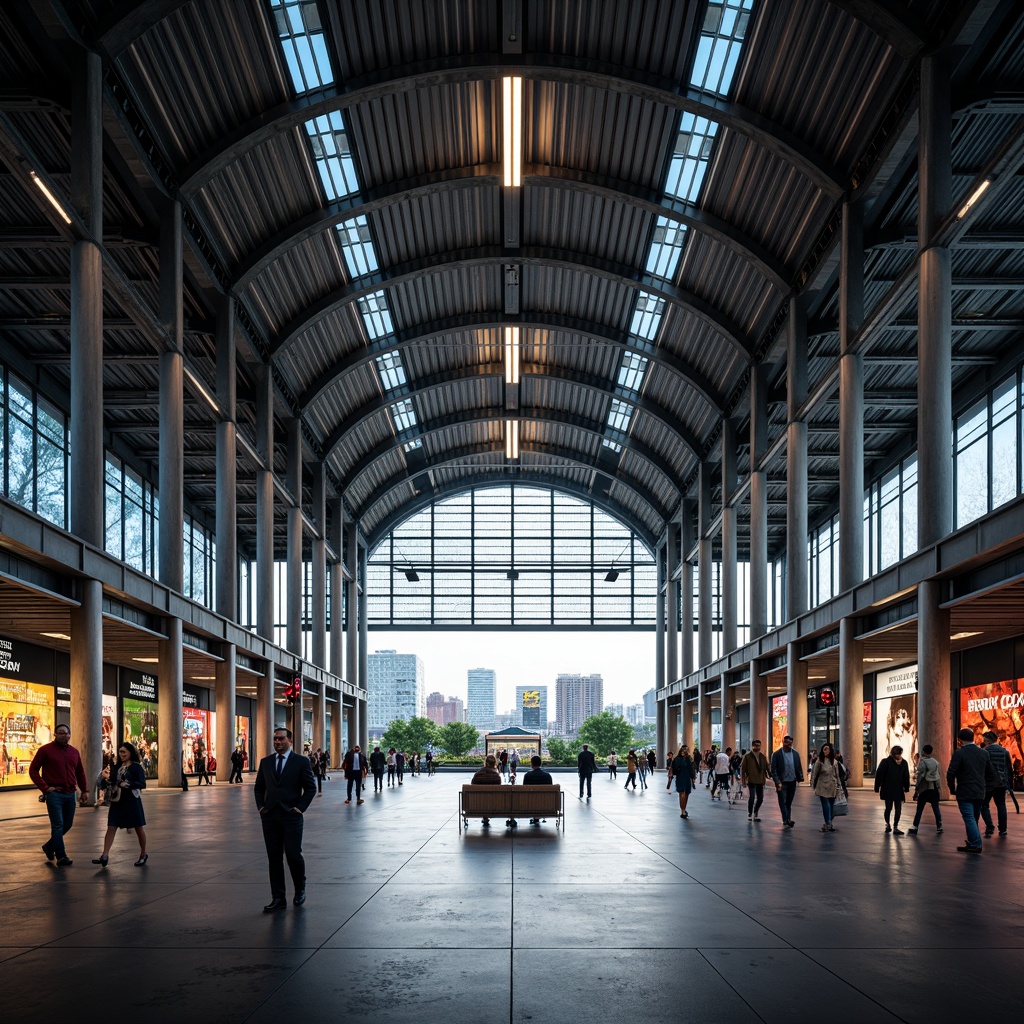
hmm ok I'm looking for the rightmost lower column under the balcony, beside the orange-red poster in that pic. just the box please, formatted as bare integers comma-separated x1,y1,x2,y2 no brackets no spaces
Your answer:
921,580,956,800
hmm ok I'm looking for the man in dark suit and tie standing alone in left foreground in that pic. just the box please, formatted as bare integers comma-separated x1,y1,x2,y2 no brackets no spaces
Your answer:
254,729,316,913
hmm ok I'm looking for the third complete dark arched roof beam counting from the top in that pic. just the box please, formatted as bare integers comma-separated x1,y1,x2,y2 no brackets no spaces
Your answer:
270,246,754,364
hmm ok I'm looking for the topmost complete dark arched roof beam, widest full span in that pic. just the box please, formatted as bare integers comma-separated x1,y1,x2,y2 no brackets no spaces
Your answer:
180,54,848,200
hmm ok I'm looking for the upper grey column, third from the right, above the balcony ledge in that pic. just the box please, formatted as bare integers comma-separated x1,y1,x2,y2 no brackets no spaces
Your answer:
785,297,808,618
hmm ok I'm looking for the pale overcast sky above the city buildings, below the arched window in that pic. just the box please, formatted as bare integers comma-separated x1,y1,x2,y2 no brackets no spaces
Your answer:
369,630,654,716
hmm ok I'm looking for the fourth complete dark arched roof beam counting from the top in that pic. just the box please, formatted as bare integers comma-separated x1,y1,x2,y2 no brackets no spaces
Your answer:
299,313,725,416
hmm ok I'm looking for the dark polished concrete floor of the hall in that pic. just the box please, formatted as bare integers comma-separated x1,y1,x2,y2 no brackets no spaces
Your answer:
0,773,1024,1024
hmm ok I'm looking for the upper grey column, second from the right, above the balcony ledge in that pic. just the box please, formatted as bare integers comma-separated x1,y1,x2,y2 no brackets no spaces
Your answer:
839,203,864,591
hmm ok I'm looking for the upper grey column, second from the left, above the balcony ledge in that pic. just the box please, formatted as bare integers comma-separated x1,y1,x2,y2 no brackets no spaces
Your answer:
160,203,185,593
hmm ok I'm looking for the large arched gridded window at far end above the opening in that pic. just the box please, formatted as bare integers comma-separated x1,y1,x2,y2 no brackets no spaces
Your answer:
367,485,657,630
